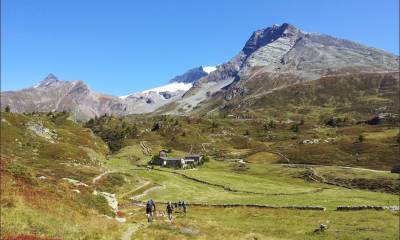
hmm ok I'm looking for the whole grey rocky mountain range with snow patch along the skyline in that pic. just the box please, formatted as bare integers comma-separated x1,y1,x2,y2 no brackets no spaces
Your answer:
1,23,399,120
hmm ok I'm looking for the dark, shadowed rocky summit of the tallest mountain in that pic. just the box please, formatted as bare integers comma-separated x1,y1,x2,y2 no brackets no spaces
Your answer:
243,23,301,55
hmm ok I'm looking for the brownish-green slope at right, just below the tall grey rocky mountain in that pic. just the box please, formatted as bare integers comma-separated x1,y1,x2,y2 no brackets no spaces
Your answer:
220,73,400,122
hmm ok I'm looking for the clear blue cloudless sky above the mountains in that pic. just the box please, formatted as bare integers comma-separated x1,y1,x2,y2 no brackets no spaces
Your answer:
1,0,399,95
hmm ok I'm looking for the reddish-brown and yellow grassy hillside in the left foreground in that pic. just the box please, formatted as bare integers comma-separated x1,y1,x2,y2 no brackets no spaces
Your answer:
1,112,128,239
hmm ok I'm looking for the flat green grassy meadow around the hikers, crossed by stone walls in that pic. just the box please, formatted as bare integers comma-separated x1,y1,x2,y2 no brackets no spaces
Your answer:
102,155,399,239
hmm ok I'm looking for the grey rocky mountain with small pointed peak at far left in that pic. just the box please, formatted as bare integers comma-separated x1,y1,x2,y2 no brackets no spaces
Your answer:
1,74,125,120
